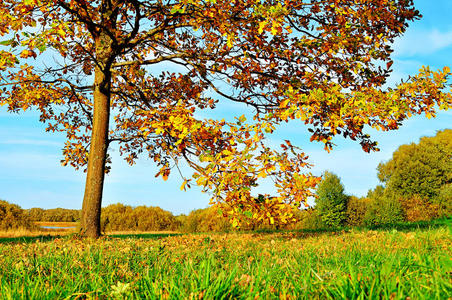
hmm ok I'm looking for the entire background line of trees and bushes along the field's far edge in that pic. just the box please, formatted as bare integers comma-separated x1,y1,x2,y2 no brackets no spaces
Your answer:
0,129,452,232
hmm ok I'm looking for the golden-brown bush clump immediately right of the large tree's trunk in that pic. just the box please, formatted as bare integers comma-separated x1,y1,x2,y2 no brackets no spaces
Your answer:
101,203,181,231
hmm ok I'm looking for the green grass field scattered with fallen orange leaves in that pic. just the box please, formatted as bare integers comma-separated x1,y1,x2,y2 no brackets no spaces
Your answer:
0,219,452,299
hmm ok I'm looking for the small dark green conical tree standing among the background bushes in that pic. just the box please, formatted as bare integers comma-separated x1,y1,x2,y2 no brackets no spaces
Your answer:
315,171,348,227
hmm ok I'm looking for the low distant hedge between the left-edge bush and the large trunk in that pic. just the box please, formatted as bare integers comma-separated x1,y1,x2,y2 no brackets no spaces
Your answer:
26,207,81,222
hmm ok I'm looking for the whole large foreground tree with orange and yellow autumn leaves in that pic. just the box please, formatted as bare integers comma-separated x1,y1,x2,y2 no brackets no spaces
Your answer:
0,0,451,237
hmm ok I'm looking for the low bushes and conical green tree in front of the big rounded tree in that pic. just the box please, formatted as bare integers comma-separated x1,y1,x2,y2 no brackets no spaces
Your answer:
294,172,451,229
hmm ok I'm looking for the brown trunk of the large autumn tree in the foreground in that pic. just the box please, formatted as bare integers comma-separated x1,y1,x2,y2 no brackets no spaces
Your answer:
80,34,111,238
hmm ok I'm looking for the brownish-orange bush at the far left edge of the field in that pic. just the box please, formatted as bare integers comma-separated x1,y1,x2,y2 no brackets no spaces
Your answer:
0,200,36,231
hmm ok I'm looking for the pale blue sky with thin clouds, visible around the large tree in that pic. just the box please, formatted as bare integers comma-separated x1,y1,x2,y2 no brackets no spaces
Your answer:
0,0,452,214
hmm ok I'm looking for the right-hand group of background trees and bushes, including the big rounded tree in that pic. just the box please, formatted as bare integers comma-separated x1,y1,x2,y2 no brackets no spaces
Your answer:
303,129,452,227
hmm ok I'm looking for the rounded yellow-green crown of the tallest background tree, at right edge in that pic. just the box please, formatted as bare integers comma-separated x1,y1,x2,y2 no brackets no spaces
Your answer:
378,129,452,200
